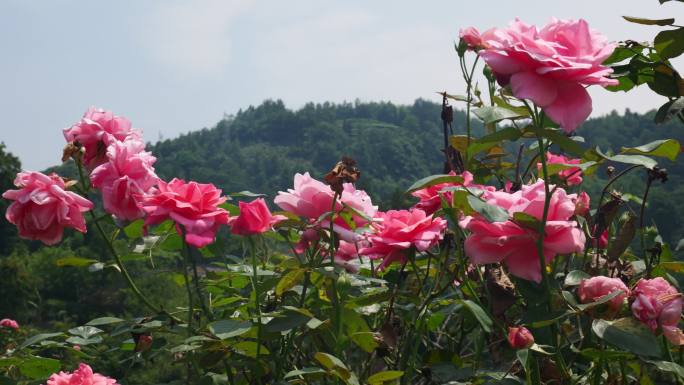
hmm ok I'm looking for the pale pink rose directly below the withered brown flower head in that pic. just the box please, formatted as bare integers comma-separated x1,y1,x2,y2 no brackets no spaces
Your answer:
274,172,378,242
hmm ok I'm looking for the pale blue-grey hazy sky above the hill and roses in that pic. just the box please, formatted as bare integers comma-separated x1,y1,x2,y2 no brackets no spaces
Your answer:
0,0,684,170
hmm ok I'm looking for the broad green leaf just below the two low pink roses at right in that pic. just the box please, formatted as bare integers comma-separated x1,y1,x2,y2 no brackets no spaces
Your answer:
591,318,661,357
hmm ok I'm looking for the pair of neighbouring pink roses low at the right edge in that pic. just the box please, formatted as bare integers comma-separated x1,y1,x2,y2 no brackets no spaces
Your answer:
578,276,684,345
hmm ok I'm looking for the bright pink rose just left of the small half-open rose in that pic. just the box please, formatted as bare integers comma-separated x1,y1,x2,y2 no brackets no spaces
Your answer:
142,178,229,247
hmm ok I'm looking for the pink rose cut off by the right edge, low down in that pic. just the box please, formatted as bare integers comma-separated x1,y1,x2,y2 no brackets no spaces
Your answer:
632,277,684,345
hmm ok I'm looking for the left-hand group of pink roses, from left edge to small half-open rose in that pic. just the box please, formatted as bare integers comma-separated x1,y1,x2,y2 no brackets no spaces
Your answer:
3,108,284,247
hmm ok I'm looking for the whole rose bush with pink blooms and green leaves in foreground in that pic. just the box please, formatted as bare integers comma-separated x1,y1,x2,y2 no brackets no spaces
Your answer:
0,10,684,385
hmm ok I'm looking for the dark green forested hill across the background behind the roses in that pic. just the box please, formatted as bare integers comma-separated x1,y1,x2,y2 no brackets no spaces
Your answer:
150,99,684,241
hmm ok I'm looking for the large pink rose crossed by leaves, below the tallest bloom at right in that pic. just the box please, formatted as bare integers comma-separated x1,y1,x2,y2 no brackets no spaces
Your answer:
459,179,585,282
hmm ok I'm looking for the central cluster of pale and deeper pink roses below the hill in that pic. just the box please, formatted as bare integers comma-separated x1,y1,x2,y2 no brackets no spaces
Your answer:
275,173,447,268
